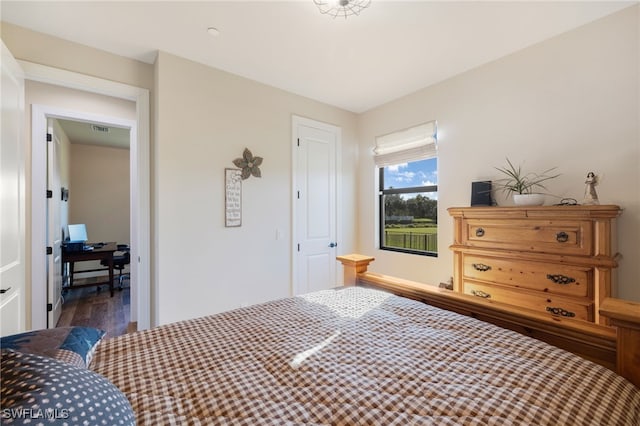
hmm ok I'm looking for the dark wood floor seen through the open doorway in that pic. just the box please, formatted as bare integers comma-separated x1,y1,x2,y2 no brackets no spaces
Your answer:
57,278,135,338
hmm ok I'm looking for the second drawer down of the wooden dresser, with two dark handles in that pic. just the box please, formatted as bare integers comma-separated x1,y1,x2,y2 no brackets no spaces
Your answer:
463,255,593,297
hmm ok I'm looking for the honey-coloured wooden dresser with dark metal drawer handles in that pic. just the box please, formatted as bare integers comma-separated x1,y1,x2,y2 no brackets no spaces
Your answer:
448,205,621,324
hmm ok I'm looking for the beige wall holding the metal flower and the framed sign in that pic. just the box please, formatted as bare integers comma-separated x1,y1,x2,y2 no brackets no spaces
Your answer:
153,52,357,323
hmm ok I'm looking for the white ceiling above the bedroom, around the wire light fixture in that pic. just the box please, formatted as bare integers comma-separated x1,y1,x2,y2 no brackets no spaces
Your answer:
0,0,637,113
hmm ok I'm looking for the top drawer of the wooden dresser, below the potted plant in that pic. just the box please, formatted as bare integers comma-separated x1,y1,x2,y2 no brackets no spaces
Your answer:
462,219,593,256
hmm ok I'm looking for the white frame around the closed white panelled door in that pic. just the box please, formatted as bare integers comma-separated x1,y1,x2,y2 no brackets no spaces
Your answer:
289,115,343,296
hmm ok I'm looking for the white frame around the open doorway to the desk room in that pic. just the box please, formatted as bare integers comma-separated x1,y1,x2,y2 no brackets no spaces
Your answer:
18,61,152,330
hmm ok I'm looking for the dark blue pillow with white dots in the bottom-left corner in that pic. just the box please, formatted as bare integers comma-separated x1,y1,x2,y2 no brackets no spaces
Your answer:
0,349,135,426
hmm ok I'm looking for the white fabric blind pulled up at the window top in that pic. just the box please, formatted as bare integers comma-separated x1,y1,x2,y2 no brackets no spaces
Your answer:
373,121,438,167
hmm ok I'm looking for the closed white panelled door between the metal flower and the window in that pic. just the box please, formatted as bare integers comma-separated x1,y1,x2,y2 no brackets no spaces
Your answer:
293,117,340,294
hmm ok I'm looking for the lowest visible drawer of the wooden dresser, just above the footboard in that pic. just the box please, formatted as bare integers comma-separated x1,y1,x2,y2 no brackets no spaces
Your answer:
463,281,593,321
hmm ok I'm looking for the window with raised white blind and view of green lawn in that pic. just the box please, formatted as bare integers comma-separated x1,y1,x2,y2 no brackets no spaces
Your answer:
375,122,438,256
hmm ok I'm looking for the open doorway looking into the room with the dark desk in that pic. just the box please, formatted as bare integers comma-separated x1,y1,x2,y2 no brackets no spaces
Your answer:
32,104,139,334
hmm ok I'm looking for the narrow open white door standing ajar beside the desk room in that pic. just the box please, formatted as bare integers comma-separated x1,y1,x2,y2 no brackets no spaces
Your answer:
47,119,62,328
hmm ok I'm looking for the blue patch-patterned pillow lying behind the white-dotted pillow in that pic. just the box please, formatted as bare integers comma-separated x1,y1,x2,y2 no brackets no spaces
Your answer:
0,327,105,368
